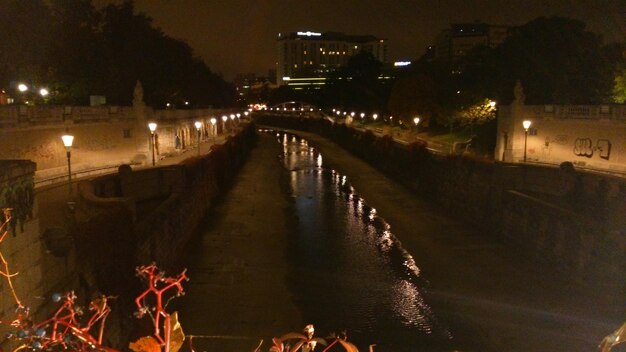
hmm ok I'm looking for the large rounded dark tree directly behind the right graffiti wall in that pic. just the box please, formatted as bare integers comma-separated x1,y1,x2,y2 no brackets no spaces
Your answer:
492,17,613,104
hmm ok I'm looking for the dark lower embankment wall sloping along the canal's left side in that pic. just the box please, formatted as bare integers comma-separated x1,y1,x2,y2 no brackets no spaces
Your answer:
77,125,256,294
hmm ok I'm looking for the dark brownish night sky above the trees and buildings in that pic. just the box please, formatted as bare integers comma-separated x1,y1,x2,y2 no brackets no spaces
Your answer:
100,0,626,80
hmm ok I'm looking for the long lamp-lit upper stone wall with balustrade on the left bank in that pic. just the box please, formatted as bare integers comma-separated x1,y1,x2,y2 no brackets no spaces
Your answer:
0,106,238,182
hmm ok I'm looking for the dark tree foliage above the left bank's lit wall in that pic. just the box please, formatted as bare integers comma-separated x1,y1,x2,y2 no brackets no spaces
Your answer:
0,0,235,107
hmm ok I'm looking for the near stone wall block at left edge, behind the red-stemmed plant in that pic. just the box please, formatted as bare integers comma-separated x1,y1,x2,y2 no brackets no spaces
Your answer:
0,160,75,350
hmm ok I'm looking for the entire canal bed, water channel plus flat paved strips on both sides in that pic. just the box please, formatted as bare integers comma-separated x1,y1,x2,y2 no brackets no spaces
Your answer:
176,130,617,352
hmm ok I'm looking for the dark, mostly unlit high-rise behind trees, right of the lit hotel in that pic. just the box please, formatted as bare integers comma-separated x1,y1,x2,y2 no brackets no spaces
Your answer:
435,22,509,60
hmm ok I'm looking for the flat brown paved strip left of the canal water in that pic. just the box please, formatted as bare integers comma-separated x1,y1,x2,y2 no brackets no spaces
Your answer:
176,133,304,351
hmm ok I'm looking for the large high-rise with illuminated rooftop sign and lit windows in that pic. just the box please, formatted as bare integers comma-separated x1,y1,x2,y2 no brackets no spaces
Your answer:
276,31,387,85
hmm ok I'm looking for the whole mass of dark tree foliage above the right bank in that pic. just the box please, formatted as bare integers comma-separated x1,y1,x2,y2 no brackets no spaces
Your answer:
389,17,626,133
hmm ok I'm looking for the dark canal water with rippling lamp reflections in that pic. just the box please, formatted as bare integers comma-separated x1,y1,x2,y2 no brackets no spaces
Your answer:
276,131,452,351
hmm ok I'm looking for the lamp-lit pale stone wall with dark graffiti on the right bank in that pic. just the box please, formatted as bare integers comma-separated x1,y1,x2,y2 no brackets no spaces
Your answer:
495,104,626,175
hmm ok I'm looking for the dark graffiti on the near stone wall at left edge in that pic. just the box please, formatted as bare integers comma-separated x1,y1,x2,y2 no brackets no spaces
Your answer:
0,176,35,236
